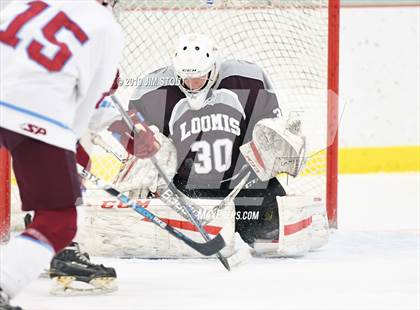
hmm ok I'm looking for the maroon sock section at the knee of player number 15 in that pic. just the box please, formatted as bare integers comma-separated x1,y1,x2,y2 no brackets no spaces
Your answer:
23,207,77,253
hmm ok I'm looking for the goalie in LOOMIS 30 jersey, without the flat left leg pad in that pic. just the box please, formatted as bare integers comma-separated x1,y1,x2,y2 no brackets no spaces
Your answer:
84,34,326,256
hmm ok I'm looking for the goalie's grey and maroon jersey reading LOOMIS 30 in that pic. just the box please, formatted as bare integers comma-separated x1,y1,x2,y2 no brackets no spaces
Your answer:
130,60,280,189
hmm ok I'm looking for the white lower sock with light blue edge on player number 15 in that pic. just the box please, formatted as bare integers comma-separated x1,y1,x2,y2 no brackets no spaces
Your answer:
0,236,54,298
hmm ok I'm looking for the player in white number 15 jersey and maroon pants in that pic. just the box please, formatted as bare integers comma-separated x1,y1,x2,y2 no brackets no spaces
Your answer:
0,0,157,310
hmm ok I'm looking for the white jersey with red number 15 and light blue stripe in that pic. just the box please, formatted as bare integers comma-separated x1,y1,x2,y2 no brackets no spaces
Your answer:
0,0,123,151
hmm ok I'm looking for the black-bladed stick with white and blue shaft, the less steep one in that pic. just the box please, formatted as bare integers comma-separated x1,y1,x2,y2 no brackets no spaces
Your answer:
77,165,226,256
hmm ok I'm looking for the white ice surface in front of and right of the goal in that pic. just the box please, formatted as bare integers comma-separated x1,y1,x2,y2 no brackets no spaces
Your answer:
14,174,420,310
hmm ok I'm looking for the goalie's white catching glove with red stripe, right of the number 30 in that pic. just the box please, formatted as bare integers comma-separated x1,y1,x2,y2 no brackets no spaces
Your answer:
240,118,305,181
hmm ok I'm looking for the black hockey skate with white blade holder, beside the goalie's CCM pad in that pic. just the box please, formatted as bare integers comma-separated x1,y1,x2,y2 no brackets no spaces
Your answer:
49,242,117,295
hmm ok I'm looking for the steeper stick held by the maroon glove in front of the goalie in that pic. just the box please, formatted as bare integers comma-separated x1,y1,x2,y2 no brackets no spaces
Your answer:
111,95,230,271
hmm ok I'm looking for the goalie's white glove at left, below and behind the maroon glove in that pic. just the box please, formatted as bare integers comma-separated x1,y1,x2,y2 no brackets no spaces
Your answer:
114,126,177,199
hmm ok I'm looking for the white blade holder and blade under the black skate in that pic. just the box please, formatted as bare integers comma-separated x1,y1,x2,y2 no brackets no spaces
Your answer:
50,276,118,296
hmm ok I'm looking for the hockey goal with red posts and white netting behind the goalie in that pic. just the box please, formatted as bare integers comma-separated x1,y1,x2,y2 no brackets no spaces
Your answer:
0,0,340,241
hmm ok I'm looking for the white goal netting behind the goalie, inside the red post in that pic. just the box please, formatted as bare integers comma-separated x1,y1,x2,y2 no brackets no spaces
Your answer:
113,0,328,196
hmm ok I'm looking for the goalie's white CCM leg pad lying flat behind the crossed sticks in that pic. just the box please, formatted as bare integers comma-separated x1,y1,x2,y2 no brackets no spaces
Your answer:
77,198,235,258
